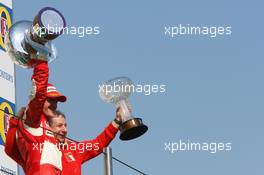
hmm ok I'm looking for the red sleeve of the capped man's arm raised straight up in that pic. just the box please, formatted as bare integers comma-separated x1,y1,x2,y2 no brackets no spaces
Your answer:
25,61,49,128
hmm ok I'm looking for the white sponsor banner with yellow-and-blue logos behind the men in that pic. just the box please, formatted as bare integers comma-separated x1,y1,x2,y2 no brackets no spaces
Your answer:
0,0,18,175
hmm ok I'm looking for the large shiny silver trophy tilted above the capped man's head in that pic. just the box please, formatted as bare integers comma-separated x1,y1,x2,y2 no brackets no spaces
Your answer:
5,7,66,68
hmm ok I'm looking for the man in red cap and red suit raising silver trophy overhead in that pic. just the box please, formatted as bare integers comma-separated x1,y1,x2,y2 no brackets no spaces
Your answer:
5,60,66,175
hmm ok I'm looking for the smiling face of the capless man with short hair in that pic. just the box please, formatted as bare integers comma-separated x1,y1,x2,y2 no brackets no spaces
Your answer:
50,115,67,143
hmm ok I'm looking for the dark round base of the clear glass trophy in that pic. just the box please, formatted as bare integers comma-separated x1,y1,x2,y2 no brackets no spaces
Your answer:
119,118,148,140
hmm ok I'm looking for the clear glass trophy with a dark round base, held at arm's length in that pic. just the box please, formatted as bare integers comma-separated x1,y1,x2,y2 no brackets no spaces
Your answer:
99,77,148,140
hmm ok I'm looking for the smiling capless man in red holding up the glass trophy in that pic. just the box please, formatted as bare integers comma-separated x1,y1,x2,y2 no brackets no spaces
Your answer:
49,109,121,175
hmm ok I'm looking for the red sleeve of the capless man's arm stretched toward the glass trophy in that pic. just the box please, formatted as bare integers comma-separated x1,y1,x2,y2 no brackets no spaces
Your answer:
79,122,118,163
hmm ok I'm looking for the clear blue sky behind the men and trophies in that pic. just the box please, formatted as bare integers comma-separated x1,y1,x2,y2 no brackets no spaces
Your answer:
13,0,264,175
